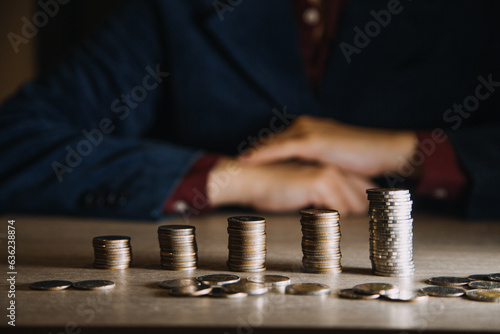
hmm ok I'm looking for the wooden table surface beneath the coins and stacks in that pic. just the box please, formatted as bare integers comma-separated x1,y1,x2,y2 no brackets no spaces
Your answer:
0,212,500,334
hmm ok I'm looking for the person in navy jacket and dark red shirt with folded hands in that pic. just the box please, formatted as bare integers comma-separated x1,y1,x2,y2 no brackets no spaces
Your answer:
0,0,500,219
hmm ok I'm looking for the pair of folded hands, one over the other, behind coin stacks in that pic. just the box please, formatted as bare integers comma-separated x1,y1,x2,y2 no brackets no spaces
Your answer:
207,116,416,215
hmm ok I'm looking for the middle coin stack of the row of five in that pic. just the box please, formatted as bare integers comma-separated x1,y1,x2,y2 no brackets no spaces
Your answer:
227,216,267,272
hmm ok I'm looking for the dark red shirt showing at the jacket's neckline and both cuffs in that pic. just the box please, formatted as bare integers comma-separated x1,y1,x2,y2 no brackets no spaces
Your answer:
165,0,469,214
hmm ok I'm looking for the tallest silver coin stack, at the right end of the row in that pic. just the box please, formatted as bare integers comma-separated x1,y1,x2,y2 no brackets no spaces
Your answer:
366,188,415,277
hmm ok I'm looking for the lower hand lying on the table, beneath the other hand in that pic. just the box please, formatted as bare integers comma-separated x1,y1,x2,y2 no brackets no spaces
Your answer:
207,158,376,215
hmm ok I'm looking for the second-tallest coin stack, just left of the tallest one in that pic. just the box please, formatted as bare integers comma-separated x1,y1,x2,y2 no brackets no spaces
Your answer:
300,209,342,273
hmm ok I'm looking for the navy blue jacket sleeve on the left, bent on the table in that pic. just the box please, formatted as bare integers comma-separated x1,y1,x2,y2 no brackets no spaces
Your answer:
0,1,203,219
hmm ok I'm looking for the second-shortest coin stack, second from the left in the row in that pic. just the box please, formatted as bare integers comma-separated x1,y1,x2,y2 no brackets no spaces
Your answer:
158,225,198,270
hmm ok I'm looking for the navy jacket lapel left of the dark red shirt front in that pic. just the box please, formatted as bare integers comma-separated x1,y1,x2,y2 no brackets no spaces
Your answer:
202,0,311,106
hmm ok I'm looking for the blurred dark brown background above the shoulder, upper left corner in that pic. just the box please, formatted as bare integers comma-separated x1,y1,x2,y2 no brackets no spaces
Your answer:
0,0,126,103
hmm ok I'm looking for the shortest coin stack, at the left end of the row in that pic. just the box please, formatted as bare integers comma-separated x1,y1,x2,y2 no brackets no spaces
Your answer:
92,235,132,269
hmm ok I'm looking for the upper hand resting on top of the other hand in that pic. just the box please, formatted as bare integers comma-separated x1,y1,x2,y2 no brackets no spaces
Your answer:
239,116,417,177
